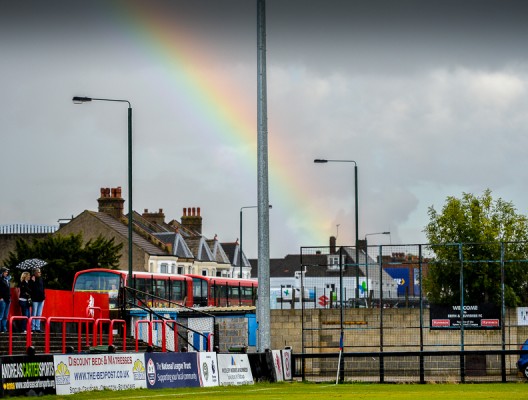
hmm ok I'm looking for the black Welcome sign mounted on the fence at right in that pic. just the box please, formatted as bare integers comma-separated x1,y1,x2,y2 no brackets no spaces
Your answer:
430,304,501,330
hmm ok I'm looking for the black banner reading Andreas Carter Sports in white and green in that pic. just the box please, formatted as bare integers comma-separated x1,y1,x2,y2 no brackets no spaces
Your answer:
1,355,56,397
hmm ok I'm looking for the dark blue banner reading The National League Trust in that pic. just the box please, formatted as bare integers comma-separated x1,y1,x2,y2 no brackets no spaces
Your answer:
145,353,200,389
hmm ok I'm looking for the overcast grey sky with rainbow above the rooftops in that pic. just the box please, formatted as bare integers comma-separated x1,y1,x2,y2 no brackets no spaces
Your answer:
0,0,528,257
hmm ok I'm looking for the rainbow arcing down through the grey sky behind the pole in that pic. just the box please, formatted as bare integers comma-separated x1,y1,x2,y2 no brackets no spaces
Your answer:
114,1,333,246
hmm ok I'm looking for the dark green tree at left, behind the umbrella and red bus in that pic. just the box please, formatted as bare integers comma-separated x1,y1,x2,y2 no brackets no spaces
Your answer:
4,233,123,290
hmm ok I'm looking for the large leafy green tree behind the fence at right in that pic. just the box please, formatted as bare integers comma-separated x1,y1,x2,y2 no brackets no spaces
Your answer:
423,189,528,306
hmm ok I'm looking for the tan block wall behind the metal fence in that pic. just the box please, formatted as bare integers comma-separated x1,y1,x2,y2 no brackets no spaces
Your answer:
271,308,528,353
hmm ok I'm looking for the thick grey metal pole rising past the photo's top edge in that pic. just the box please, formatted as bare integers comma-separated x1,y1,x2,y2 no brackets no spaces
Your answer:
257,0,271,352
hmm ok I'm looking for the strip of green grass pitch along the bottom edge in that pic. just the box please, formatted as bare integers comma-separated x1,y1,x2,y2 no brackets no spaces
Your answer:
40,382,528,400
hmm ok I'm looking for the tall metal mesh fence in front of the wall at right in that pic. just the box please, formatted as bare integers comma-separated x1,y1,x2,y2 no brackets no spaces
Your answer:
294,243,528,382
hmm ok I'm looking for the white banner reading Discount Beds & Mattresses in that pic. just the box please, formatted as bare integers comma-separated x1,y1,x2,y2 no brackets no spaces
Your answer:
53,353,147,395
